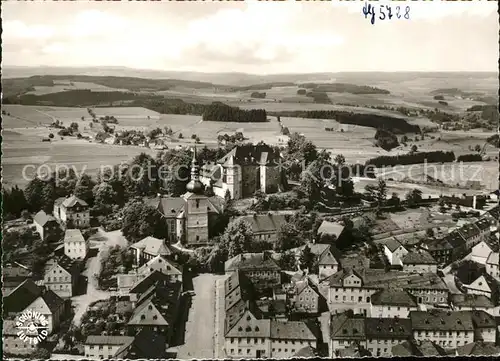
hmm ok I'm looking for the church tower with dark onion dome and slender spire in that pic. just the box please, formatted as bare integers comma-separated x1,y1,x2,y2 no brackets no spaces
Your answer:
184,147,209,246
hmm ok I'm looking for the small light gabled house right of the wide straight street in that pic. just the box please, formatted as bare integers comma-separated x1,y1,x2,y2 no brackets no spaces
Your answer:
291,278,326,314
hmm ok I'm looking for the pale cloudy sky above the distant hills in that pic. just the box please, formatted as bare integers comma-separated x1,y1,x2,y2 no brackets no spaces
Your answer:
2,0,499,74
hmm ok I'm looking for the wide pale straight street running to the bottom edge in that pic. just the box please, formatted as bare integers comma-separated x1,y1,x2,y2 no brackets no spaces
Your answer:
177,274,225,359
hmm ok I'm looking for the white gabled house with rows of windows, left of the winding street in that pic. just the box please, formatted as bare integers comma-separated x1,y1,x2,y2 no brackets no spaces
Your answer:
43,256,80,298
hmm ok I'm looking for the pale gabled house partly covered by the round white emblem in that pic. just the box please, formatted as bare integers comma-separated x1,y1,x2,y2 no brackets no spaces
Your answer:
23,290,65,335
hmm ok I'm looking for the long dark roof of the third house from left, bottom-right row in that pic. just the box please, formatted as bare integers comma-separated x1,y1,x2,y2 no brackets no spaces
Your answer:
410,309,474,331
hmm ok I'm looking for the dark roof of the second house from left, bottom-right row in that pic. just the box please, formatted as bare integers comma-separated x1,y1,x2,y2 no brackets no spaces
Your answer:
365,318,412,339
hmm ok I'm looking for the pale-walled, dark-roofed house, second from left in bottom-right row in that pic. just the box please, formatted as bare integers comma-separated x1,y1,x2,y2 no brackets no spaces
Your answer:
365,317,412,357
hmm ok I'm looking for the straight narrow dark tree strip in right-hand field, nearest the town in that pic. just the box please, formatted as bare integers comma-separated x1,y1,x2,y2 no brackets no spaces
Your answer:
366,150,455,167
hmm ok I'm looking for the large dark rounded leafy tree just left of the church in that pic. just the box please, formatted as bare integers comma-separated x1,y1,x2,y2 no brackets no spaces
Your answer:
122,201,167,242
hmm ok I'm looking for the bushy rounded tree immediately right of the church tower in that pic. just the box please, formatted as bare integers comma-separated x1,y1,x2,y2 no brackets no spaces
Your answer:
221,219,253,258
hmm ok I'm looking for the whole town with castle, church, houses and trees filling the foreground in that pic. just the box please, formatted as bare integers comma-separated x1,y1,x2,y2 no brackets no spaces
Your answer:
3,135,500,359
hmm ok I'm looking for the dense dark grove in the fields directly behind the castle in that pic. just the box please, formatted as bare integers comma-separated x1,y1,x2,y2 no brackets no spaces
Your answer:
203,102,267,122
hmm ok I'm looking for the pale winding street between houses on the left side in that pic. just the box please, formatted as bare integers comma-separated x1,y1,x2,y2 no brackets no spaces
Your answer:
71,229,127,326
